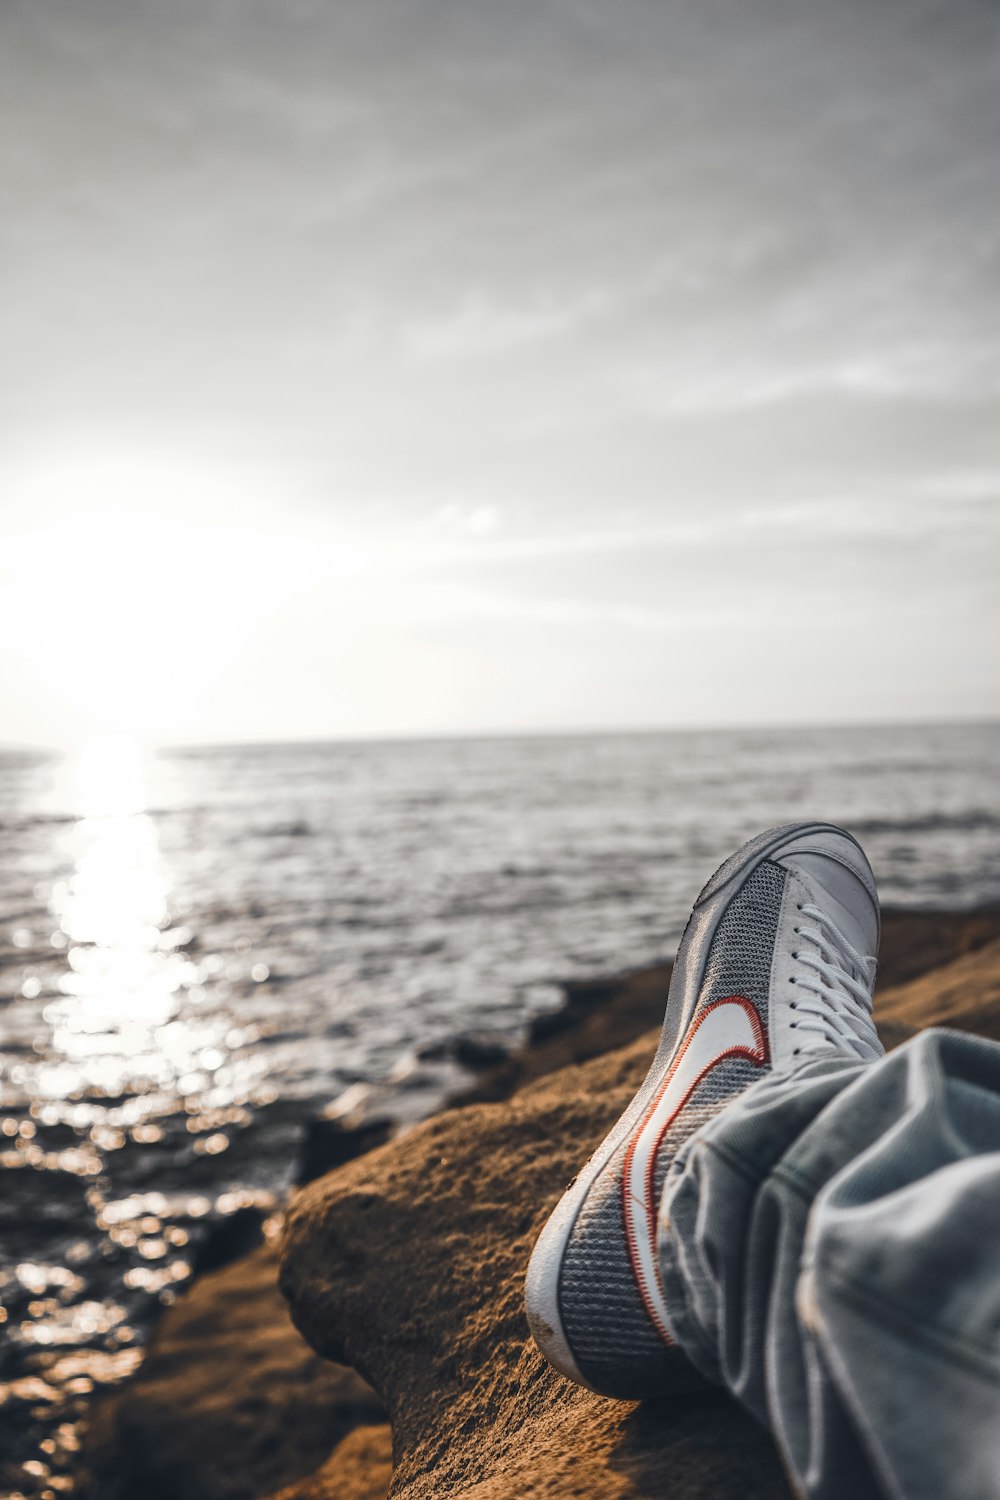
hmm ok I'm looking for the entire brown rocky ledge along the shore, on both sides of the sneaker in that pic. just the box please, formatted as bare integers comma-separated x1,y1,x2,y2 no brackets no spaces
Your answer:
88,912,1000,1500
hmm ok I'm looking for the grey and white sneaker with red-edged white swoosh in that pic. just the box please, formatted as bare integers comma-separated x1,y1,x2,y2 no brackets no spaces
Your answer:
525,824,883,1400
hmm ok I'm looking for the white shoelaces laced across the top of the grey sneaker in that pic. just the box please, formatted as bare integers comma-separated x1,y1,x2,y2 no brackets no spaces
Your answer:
792,905,882,1058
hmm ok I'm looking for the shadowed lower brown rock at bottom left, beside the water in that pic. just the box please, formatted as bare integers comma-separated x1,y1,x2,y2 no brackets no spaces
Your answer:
79,1247,382,1500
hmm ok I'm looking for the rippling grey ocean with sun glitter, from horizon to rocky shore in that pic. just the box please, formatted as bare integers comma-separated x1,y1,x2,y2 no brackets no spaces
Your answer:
0,725,1000,1496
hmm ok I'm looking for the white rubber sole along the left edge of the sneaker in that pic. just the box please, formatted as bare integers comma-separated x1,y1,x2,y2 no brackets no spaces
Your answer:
525,824,856,1394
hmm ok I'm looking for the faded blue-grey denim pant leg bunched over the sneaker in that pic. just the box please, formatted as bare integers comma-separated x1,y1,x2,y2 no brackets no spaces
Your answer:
660,1031,1000,1500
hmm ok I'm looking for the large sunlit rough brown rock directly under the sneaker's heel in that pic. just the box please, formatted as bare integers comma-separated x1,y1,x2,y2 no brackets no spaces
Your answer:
282,1035,789,1500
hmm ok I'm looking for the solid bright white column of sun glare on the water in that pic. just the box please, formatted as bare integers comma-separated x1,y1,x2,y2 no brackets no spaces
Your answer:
32,735,267,1125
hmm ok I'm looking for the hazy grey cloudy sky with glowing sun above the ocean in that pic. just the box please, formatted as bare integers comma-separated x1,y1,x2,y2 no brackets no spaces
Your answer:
0,0,1000,744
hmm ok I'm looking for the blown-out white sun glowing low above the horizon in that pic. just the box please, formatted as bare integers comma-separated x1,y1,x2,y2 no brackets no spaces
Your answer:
0,458,290,740
